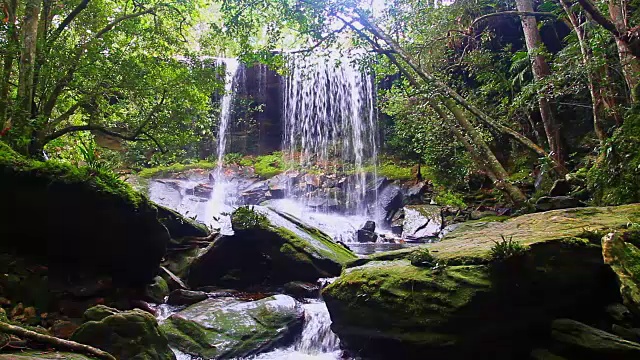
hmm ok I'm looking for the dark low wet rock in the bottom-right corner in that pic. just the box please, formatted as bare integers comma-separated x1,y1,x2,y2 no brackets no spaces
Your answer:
551,319,640,360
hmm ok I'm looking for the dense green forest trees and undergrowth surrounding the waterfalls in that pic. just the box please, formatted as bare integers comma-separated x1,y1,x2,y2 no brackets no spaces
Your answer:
0,0,640,204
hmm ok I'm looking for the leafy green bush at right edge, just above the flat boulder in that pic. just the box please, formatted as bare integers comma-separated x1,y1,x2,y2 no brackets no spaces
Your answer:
587,107,640,205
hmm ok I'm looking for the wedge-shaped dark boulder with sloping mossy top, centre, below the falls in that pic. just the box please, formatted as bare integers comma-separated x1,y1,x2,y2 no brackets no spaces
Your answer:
188,207,356,288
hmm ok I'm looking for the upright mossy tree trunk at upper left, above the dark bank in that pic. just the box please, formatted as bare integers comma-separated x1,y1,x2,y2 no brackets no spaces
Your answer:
14,0,41,153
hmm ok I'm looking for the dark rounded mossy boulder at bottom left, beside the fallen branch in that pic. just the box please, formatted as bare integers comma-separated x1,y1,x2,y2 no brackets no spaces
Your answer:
71,307,175,360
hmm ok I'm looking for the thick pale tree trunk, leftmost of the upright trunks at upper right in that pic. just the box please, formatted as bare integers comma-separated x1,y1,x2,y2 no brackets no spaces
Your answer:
516,0,565,165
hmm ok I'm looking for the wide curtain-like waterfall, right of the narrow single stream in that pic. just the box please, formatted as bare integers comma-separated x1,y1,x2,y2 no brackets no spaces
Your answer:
282,53,378,214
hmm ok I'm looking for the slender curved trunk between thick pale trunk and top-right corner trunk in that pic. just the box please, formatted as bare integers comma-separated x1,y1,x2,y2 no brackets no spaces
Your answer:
560,0,607,142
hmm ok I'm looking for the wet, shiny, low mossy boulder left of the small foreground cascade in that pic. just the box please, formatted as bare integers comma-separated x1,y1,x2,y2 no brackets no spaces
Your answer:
161,295,304,359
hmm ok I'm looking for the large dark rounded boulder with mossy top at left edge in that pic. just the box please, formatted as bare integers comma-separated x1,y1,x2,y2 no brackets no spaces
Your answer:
0,142,170,286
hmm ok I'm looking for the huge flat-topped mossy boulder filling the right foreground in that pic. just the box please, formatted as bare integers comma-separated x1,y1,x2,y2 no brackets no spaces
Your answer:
323,205,640,359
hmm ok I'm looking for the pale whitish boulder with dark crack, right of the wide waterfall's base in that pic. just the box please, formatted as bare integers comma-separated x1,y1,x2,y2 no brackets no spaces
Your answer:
402,205,442,240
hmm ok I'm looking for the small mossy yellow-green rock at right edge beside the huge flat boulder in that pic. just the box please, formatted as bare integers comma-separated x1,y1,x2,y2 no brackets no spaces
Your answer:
602,230,640,317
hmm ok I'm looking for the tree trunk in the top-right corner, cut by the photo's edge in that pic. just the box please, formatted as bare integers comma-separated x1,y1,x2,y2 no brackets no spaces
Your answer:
609,0,640,102
